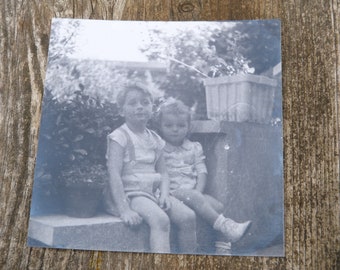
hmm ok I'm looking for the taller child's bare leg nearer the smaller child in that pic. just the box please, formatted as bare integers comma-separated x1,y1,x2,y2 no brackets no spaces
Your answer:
168,196,197,253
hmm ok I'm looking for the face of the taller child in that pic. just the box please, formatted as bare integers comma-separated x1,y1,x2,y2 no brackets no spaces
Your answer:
121,90,152,124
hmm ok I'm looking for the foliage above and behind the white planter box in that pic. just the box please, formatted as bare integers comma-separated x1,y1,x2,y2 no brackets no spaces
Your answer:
142,20,280,118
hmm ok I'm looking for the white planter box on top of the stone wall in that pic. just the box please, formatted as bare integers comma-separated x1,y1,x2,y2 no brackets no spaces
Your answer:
204,74,277,123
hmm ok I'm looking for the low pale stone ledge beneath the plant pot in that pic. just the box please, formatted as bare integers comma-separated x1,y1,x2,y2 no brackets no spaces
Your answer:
28,214,149,252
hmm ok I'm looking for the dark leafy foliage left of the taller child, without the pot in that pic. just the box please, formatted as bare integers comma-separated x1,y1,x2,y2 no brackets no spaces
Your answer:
32,80,122,214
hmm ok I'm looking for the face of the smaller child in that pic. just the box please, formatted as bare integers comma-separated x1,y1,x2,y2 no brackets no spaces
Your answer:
161,113,189,146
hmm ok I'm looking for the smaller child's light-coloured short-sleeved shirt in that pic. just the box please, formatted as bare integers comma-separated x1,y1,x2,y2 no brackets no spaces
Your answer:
164,139,207,190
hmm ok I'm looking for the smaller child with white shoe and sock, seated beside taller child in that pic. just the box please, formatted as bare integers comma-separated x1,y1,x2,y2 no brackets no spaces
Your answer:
158,99,251,254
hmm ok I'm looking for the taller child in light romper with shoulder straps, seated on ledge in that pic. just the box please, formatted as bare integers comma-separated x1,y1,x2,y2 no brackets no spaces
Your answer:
105,85,196,253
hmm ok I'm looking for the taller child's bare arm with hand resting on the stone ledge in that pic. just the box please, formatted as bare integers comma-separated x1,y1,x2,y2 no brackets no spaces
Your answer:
107,141,142,225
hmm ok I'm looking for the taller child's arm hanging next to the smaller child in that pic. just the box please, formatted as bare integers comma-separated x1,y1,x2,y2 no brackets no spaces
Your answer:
156,153,171,210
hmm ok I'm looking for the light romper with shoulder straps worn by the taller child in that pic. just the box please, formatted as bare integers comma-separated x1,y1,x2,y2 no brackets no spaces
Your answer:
104,124,165,215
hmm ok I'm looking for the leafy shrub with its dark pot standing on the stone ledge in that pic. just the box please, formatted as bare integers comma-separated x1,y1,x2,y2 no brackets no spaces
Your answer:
57,89,120,217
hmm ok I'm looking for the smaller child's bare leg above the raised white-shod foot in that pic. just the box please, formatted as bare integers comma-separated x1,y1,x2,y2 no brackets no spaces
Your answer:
172,189,219,225
